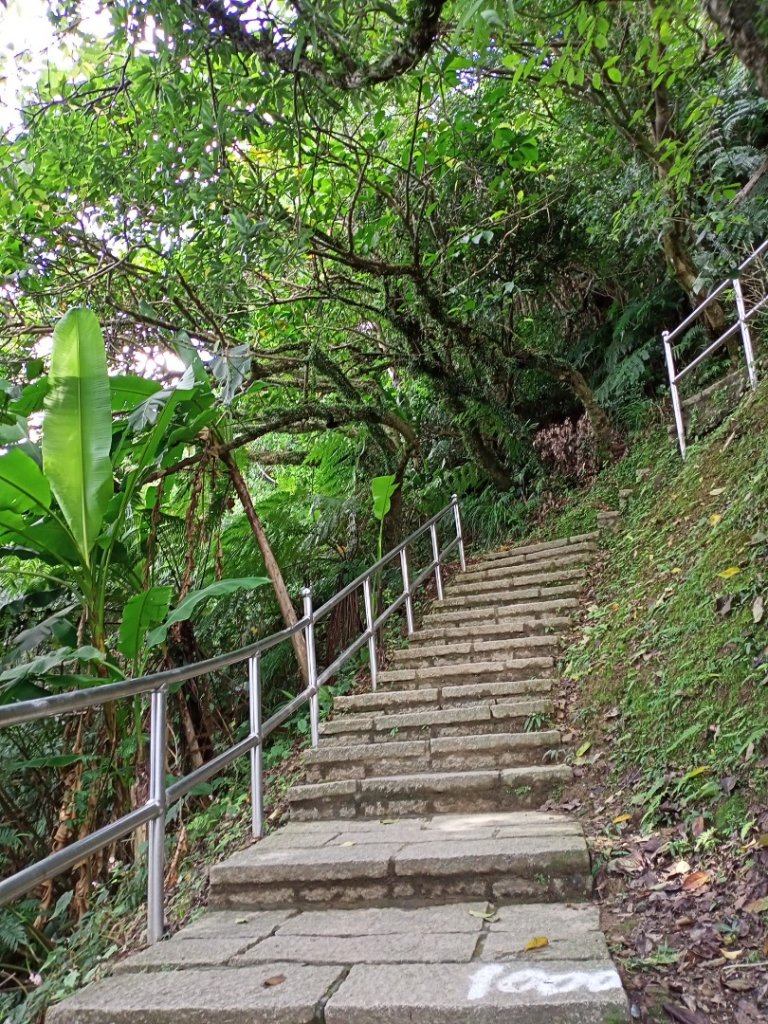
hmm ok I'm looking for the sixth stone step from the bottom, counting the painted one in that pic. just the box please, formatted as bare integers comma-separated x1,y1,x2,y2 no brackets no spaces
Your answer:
334,677,552,714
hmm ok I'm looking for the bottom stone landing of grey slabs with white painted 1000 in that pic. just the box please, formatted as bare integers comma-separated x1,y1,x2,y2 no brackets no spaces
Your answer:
47,899,630,1024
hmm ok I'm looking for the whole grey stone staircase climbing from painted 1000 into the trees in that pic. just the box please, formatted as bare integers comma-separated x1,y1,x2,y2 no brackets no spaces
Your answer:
48,535,630,1024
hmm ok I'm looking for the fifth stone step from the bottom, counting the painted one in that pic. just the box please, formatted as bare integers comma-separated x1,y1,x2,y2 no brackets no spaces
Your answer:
321,697,552,743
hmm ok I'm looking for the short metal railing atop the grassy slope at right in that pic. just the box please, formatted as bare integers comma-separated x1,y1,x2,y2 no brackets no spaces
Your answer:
662,239,768,459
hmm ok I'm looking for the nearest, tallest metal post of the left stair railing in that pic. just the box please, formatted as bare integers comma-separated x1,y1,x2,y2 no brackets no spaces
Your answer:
146,687,168,945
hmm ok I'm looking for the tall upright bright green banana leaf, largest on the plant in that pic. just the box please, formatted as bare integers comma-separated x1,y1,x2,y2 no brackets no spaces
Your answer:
43,309,113,565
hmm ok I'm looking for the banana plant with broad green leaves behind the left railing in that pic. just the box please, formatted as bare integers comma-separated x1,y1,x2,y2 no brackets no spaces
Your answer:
0,308,268,701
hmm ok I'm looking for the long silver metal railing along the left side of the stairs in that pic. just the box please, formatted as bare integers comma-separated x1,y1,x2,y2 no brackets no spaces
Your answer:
0,495,466,943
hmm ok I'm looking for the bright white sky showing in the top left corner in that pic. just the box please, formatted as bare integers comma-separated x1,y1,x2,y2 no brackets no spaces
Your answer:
0,0,110,131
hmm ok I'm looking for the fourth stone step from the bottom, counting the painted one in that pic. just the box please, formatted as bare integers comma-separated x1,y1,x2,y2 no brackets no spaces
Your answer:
305,729,560,782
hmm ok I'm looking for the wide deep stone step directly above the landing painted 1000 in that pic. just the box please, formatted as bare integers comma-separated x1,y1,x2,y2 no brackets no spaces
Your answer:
209,810,592,909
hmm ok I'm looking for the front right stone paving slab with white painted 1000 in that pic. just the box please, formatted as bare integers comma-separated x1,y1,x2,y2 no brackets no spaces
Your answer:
325,961,630,1024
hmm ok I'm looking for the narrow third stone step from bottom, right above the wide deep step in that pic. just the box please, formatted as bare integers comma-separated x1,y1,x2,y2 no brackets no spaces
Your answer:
288,765,572,821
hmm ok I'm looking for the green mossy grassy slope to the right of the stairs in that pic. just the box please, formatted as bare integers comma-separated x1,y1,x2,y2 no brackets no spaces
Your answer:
548,382,768,831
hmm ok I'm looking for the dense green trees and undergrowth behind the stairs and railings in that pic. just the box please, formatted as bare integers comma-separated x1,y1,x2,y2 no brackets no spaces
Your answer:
0,0,768,1020
